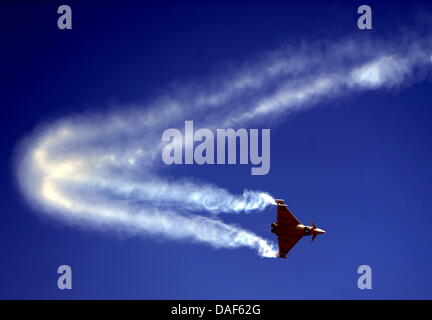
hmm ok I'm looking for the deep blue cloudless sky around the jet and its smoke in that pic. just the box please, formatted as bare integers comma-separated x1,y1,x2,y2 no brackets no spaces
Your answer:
0,1,432,299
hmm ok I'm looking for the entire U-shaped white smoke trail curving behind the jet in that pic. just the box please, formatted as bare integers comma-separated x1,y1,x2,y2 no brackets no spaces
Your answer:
12,31,430,257
